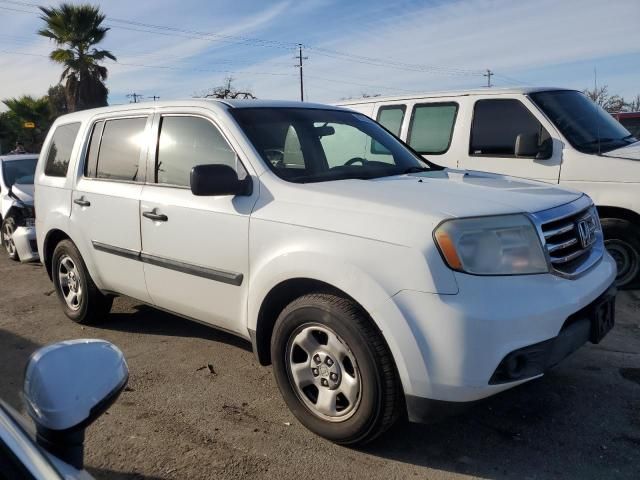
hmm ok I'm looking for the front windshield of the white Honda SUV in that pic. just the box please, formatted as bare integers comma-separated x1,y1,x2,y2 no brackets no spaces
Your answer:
231,108,429,183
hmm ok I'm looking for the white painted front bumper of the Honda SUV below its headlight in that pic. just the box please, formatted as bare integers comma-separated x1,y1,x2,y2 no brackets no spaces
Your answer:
376,254,616,419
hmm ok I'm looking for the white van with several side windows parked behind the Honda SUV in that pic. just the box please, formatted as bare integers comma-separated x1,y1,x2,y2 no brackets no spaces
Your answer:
340,88,640,286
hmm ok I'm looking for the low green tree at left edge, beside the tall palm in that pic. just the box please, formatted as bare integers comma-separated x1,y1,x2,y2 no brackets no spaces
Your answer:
0,95,52,152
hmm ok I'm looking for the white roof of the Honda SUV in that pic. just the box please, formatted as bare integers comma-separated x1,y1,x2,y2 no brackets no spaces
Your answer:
50,98,350,122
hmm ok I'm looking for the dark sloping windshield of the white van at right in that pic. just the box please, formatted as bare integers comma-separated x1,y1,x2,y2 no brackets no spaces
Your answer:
530,90,637,153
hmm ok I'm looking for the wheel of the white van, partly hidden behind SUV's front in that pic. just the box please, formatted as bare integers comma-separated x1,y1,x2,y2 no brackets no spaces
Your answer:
601,218,640,288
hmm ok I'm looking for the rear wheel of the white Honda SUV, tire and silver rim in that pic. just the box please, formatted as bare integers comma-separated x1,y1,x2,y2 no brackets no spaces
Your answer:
51,240,113,324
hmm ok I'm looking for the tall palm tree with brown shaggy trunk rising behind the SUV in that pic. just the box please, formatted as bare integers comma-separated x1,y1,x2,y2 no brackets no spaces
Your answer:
38,3,116,112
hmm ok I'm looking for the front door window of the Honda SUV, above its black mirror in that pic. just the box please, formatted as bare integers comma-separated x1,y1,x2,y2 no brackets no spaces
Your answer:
155,116,237,187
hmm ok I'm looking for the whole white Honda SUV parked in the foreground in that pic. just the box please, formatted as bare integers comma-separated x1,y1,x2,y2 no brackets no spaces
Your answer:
36,100,616,444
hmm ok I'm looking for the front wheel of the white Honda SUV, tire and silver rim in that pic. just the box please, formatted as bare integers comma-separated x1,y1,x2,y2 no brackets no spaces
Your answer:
271,293,402,445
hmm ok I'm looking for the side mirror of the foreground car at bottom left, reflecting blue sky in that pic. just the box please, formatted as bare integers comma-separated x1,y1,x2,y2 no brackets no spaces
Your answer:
23,340,129,469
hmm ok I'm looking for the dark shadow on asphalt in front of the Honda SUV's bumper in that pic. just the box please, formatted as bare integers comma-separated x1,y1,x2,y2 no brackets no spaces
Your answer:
363,360,640,479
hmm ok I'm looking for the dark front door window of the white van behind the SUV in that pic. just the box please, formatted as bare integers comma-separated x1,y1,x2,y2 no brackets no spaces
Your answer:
469,99,550,157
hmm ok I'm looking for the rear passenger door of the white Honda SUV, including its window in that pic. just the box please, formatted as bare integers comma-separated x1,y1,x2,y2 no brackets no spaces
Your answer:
70,113,152,302
